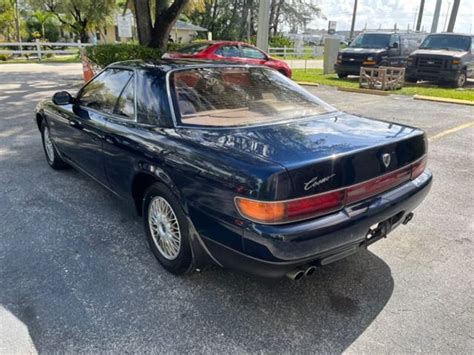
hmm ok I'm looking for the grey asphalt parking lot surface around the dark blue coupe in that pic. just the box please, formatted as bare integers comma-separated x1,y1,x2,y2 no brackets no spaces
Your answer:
0,64,474,353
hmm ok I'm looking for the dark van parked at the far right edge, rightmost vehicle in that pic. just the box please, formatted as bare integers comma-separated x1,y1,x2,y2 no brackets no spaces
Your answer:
405,33,474,87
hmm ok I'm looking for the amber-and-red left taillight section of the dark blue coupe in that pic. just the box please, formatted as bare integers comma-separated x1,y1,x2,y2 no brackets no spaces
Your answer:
235,190,344,224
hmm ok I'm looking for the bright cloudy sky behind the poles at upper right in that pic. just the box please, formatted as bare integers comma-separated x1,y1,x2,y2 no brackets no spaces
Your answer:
308,0,474,33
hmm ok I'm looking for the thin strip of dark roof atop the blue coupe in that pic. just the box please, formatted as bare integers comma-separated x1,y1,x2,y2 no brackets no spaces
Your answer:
108,59,266,73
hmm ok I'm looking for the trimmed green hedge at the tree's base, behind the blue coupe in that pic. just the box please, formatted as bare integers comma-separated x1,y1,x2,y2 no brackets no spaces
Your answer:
85,43,163,68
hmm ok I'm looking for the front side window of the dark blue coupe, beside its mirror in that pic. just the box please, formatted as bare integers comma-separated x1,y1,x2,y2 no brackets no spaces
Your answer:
78,68,133,114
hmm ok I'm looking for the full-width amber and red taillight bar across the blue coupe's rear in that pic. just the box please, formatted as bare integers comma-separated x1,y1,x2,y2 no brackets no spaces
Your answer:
235,156,426,224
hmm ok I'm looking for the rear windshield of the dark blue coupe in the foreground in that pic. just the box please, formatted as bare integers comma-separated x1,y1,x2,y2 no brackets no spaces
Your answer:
170,67,334,127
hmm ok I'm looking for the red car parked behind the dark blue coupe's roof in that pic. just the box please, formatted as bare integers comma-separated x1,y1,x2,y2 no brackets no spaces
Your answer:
163,41,291,78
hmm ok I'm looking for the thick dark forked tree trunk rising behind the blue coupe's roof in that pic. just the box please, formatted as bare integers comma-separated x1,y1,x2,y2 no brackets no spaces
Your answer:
133,0,190,50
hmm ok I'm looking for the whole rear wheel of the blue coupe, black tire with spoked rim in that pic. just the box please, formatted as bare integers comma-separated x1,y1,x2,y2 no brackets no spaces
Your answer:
143,183,193,275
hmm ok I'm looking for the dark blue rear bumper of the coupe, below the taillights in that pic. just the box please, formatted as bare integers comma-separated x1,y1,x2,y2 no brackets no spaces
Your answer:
203,170,432,278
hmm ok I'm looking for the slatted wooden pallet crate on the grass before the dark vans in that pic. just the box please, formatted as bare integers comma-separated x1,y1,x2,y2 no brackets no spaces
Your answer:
359,67,405,90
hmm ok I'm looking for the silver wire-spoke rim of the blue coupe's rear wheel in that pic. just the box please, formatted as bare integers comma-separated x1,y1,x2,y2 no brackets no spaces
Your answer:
148,196,181,260
